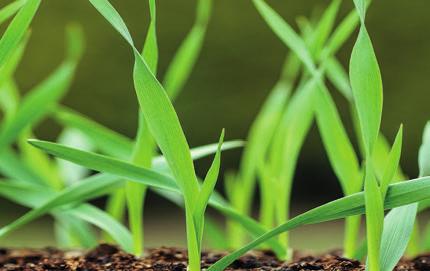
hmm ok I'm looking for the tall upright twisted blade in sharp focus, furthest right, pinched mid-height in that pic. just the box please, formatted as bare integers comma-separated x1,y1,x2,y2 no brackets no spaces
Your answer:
349,0,382,271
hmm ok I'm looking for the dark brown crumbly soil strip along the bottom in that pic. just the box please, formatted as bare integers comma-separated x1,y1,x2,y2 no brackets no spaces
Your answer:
0,244,430,271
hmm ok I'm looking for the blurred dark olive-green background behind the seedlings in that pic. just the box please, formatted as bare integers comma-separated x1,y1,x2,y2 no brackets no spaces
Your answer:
0,0,430,251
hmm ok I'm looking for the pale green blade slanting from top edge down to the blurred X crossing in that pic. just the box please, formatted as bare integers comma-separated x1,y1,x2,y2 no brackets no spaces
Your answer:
253,0,316,71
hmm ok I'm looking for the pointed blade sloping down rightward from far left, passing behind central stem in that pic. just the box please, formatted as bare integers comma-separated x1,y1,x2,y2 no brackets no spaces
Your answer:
31,141,283,255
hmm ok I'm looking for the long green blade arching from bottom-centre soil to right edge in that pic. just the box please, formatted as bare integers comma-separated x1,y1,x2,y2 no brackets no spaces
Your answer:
208,177,430,271
